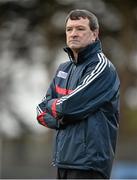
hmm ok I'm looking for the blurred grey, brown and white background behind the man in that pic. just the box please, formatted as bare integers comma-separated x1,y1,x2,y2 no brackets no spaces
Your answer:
0,0,137,179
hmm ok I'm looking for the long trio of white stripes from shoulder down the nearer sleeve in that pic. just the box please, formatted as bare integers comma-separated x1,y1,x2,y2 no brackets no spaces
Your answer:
57,53,108,105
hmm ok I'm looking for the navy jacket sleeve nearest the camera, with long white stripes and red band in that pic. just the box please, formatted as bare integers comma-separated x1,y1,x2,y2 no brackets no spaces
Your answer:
47,57,119,121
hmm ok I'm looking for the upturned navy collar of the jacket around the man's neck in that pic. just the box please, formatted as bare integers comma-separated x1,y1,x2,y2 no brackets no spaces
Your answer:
64,39,102,64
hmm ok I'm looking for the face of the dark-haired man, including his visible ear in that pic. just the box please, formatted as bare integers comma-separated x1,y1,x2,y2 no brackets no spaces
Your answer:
66,18,98,52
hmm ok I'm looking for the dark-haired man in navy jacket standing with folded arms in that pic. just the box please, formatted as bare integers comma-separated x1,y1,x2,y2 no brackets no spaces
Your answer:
37,10,120,179
